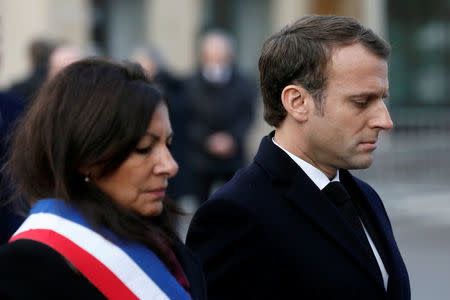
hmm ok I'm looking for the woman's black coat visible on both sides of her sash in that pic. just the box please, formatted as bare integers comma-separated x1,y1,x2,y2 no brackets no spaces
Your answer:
0,240,206,300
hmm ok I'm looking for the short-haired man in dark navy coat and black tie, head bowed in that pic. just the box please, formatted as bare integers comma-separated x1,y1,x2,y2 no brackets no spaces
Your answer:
187,16,410,300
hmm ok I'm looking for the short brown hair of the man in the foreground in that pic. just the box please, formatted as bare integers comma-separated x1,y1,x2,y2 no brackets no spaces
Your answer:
258,15,391,127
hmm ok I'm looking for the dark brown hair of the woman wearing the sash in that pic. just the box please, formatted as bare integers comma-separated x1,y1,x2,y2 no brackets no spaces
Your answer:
8,58,177,263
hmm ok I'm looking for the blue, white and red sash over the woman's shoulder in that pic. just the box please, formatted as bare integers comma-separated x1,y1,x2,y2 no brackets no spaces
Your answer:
10,199,191,300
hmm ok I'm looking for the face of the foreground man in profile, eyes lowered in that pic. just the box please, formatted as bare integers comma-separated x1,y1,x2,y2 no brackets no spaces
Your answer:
303,44,393,177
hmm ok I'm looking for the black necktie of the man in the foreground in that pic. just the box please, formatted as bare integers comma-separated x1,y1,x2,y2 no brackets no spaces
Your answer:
322,181,373,255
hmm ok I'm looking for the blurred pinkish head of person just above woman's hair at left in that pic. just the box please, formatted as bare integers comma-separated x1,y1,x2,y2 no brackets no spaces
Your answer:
47,43,83,79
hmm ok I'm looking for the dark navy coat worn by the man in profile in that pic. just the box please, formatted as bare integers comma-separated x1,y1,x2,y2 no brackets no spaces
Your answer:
187,136,410,300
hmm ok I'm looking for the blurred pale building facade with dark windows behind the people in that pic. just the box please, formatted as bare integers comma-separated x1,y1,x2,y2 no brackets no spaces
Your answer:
0,0,450,141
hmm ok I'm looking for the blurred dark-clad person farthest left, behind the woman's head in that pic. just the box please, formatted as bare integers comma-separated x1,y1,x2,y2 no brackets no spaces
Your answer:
9,38,56,103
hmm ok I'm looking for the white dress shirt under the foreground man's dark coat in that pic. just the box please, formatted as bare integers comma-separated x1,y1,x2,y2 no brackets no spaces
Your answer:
272,138,389,290
